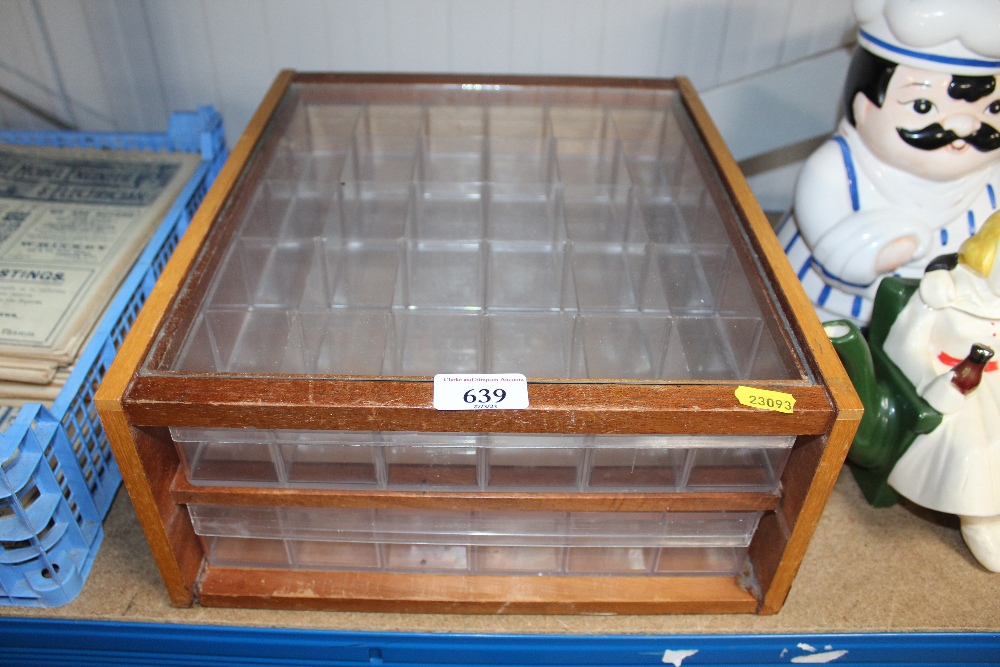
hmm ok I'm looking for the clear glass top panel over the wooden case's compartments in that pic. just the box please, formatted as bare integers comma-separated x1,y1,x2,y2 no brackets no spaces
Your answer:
143,83,806,381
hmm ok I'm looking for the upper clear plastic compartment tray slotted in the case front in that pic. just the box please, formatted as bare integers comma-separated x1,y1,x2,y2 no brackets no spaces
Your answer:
170,427,794,492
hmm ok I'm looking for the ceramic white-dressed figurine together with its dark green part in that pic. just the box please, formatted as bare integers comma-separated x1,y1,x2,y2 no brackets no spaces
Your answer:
825,212,1000,572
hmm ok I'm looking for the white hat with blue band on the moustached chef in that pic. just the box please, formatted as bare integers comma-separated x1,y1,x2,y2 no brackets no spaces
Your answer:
854,0,1000,75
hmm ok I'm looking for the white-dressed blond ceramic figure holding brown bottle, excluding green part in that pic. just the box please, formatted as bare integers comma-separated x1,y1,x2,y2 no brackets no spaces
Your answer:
884,213,1000,572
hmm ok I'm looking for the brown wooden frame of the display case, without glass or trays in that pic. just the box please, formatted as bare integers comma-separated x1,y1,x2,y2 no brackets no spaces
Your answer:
96,71,862,614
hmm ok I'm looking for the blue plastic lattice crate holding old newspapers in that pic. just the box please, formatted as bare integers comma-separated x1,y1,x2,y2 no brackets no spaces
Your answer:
0,107,227,607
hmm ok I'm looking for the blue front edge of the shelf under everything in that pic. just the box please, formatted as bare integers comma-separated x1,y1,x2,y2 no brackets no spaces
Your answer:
0,618,1000,667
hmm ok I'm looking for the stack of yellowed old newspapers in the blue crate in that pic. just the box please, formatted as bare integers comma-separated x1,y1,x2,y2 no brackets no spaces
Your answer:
0,144,199,406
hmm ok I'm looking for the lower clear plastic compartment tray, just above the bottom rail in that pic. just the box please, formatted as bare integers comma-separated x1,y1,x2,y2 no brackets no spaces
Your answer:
189,505,760,576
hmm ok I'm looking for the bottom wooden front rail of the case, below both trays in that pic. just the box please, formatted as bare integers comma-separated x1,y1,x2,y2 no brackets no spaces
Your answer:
199,565,758,614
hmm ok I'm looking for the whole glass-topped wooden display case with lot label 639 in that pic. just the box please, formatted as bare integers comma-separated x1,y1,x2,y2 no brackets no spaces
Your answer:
96,72,862,613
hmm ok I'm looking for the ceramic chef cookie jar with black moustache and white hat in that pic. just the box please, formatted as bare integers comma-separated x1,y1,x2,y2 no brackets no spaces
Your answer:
779,0,1000,326
